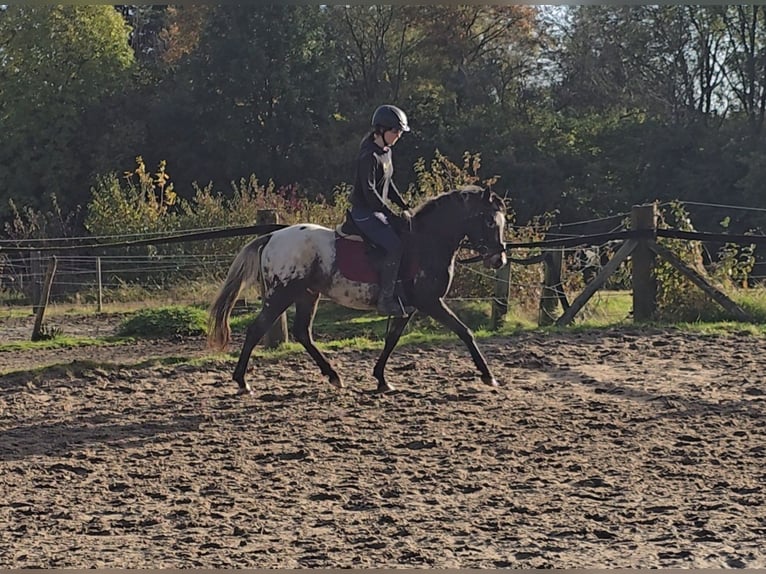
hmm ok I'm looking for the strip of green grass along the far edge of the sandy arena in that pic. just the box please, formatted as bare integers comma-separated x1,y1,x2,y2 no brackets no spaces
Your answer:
6,289,766,368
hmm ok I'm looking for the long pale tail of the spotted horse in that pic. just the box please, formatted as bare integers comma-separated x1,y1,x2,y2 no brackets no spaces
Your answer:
207,234,271,351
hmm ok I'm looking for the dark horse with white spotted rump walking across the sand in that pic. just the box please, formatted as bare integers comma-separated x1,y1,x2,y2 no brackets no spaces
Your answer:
208,186,507,394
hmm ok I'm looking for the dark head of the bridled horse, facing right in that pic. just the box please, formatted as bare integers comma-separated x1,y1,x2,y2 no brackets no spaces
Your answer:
460,187,507,269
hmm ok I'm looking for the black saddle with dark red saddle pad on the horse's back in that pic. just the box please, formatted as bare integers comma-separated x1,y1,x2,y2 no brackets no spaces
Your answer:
335,212,418,283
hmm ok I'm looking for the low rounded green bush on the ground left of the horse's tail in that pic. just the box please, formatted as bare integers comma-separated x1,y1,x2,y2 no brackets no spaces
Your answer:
118,306,207,339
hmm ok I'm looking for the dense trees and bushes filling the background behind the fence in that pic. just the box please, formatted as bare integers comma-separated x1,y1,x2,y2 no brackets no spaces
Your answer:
0,5,766,324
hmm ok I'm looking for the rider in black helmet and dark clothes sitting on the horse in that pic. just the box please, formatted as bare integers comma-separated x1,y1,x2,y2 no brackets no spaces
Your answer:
350,104,411,317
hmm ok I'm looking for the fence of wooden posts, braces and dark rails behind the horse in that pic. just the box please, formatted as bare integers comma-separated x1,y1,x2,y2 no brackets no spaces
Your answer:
0,203,766,342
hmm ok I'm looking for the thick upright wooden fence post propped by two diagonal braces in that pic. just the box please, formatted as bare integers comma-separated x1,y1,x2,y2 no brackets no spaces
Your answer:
630,203,657,321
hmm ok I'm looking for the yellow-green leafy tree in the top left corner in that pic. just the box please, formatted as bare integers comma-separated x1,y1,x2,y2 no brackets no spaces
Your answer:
0,6,134,215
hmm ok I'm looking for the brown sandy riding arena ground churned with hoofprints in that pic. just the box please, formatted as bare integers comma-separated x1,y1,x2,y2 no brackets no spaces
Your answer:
0,322,766,568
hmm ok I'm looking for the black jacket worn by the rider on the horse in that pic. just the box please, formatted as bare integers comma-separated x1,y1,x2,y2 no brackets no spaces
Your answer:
350,136,408,215
